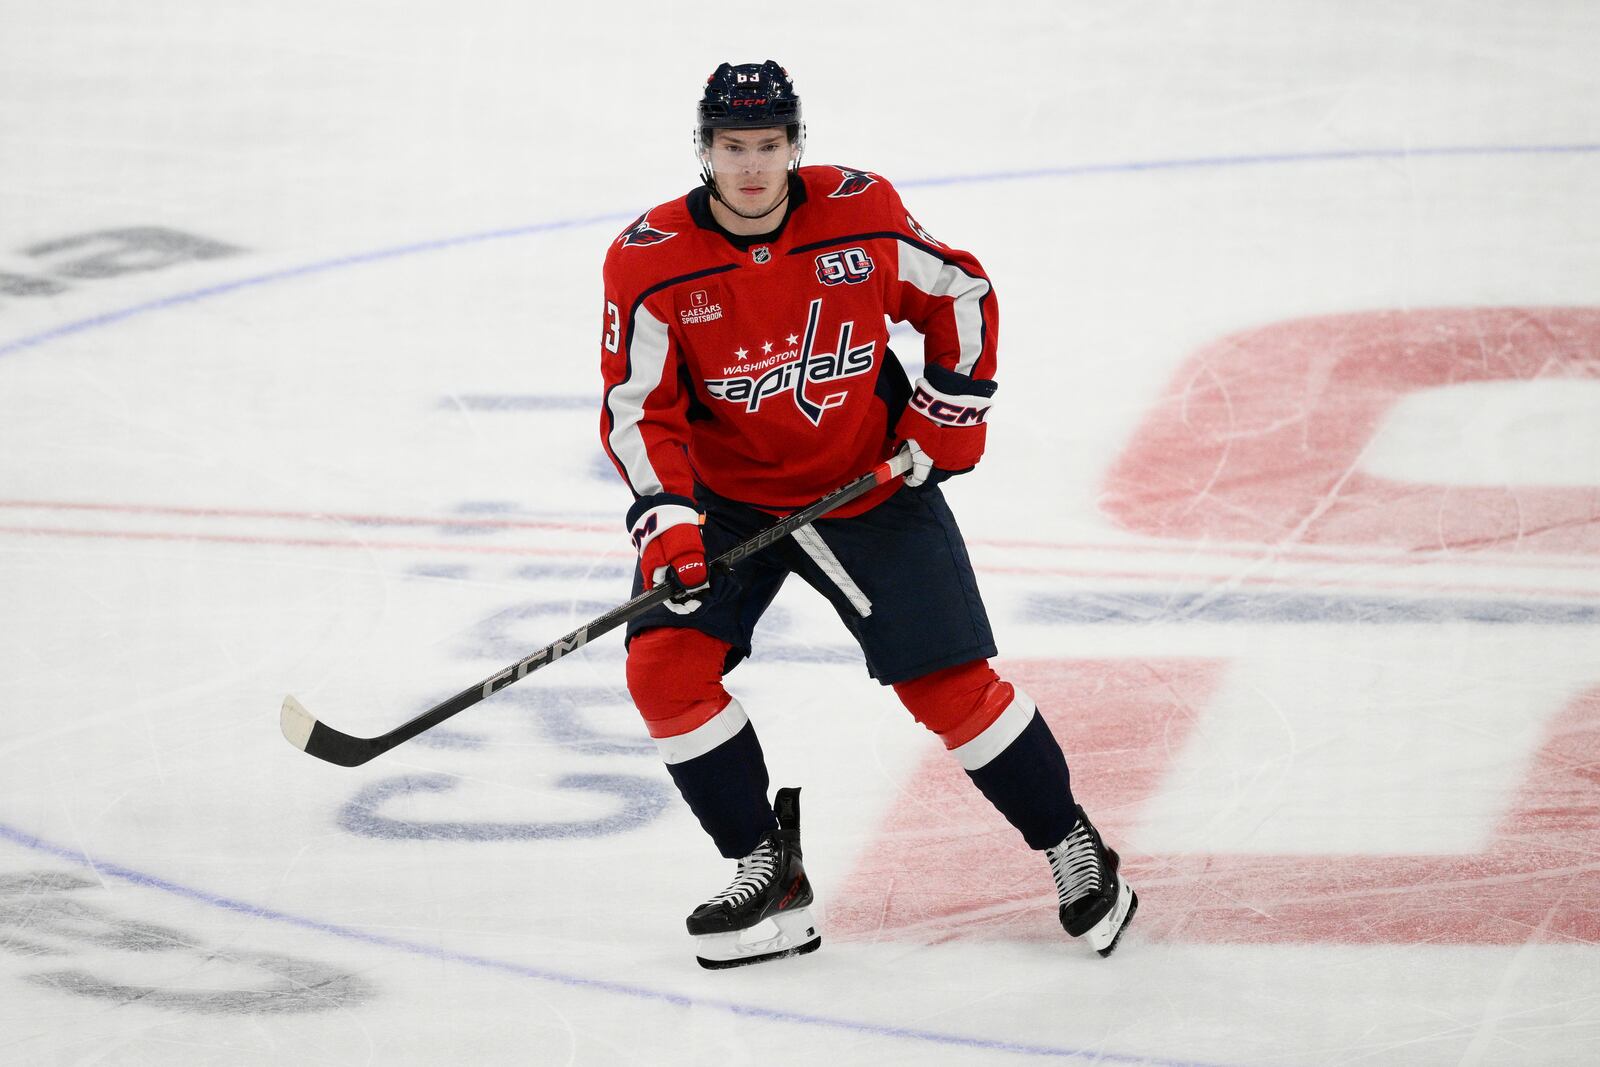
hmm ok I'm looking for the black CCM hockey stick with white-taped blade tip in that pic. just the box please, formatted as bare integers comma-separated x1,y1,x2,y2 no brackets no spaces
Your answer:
278,450,910,766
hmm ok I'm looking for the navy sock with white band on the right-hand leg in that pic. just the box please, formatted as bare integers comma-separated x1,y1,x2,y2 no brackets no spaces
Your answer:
954,693,1078,849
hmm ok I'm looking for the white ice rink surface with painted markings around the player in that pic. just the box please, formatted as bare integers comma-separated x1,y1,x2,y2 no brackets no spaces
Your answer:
0,0,1600,1067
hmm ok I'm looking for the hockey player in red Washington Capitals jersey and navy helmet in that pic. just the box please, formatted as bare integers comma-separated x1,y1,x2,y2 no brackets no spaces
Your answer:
600,61,1138,968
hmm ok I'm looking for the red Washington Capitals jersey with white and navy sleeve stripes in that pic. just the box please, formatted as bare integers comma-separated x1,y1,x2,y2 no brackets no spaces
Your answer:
600,166,998,515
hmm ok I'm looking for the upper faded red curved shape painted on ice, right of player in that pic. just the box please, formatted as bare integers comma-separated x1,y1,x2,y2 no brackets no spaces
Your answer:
1101,307,1600,555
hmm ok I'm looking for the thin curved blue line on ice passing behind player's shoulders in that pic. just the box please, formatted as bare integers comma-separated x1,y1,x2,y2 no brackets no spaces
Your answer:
0,144,1600,358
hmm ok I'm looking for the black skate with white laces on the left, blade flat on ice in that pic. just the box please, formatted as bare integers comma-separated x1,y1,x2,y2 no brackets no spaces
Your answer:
688,789,822,969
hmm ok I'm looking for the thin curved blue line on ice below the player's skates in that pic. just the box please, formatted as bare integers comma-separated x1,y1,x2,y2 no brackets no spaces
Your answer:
0,822,1218,1067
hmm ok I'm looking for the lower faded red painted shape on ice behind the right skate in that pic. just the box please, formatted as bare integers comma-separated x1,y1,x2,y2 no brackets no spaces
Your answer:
829,659,1600,945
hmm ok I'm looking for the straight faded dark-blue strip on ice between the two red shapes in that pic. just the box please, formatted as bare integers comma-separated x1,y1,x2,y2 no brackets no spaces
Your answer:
1022,592,1600,625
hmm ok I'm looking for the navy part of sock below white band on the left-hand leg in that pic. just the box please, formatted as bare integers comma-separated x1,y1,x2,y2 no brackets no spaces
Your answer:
667,723,777,859
